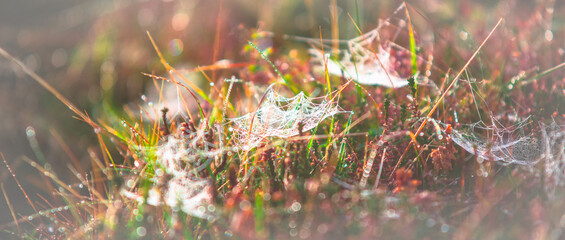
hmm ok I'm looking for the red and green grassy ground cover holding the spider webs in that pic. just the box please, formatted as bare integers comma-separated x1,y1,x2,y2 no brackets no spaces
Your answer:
0,1,565,239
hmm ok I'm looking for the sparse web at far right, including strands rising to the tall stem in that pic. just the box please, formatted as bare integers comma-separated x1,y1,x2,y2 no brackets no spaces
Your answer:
442,71,565,195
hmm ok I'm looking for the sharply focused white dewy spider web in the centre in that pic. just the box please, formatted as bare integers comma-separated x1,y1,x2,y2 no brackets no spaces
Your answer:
228,88,347,150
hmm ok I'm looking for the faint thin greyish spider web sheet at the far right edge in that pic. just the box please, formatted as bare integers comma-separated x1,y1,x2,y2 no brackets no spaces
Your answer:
450,116,565,196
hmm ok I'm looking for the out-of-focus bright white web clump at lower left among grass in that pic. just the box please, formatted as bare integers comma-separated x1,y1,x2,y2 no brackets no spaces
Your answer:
122,122,216,219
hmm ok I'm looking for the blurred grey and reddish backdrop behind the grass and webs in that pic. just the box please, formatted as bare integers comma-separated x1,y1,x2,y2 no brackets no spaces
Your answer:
0,0,565,229
